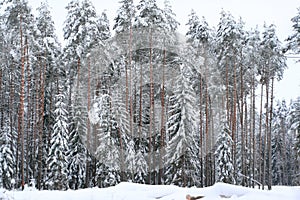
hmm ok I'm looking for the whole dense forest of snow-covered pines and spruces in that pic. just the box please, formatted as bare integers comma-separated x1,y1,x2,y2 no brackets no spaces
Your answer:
0,0,300,190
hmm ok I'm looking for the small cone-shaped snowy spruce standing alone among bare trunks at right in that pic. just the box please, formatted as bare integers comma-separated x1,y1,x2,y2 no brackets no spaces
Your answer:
215,122,235,184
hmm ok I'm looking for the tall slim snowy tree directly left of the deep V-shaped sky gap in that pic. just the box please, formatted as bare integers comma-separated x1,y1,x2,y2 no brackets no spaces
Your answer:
33,2,61,189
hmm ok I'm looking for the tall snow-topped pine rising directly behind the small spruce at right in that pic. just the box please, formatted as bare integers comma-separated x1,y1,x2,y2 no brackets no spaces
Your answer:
215,11,244,181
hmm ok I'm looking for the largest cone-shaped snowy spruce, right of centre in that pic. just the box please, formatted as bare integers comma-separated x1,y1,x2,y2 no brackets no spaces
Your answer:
165,64,199,186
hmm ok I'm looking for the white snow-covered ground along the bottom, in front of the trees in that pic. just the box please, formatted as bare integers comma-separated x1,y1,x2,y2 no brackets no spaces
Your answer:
0,183,300,200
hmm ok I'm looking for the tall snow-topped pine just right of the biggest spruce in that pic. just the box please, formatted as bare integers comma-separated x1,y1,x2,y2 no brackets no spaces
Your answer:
186,10,214,187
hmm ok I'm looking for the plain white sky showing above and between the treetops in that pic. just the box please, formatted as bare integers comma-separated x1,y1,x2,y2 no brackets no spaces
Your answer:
28,0,300,101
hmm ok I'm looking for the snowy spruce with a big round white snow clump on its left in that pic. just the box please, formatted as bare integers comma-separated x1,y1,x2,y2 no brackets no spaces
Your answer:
93,94,123,187
